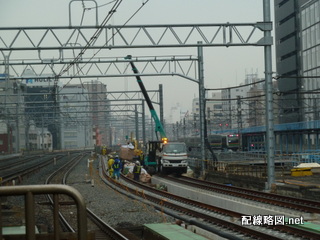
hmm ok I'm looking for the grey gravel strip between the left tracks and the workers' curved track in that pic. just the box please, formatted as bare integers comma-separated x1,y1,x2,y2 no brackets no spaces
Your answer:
68,156,174,228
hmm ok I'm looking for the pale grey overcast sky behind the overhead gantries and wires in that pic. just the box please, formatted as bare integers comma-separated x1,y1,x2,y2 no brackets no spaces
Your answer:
0,0,274,119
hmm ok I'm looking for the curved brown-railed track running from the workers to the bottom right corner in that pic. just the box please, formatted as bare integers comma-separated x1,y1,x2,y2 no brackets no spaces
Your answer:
101,158,319,239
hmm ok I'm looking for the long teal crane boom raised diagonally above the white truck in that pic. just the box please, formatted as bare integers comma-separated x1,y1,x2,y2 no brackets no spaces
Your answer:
125,55,168,143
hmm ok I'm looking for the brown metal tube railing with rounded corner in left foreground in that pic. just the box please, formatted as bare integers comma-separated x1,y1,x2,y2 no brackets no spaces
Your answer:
0,184,87,240
